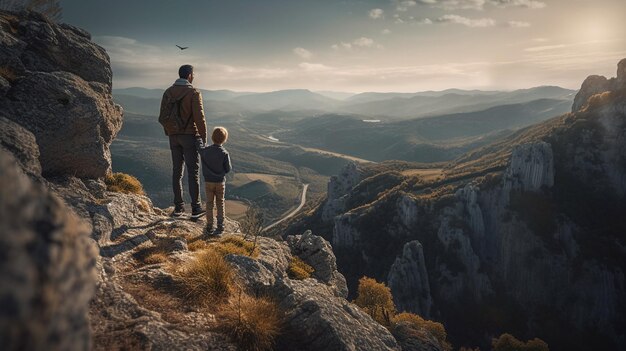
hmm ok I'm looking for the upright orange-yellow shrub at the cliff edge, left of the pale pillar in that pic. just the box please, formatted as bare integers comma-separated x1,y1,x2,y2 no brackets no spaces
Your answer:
354,277,396,327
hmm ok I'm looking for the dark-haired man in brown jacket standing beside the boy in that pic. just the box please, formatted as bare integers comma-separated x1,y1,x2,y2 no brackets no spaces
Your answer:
161,65,207,219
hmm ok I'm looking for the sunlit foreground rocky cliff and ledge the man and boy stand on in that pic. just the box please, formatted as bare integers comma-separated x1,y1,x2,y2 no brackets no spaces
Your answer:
0,11,434,350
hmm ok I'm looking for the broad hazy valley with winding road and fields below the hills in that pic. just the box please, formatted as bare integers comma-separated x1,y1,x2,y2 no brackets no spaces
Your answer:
111,87,572,224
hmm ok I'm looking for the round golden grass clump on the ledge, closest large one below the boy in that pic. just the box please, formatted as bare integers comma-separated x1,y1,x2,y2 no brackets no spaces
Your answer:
172,249,233,306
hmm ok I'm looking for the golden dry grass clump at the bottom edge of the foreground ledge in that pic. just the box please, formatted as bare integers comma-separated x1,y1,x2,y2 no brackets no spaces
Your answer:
217,292,282,351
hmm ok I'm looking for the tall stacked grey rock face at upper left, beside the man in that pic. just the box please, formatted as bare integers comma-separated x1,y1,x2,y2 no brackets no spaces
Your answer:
0,12,122,178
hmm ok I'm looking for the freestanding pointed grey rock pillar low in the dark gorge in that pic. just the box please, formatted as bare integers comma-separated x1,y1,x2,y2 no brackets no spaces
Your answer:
387,240,433,318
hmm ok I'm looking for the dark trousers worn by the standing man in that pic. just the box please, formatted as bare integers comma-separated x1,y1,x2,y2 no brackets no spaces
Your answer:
170,134,201,209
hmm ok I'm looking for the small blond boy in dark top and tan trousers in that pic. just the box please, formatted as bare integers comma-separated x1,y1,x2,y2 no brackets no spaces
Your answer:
200,127,232,236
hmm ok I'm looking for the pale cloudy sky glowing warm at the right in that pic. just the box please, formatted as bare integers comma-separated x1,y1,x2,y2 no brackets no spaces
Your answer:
61,0,626,93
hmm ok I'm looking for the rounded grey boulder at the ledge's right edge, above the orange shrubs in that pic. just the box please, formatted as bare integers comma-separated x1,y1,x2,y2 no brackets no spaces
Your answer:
287,230,348,298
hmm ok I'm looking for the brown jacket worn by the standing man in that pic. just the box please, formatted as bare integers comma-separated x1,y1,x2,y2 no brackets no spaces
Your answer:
161,81,207,143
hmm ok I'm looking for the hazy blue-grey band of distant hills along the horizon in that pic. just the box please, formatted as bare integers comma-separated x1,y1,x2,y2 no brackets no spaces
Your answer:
113,86,576,121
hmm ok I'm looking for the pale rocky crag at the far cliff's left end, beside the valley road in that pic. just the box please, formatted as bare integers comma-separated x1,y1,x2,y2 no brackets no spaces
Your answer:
322,162,361,222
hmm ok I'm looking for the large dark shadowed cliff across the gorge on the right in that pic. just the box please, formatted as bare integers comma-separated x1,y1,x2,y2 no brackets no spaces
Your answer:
294,60,626,350
